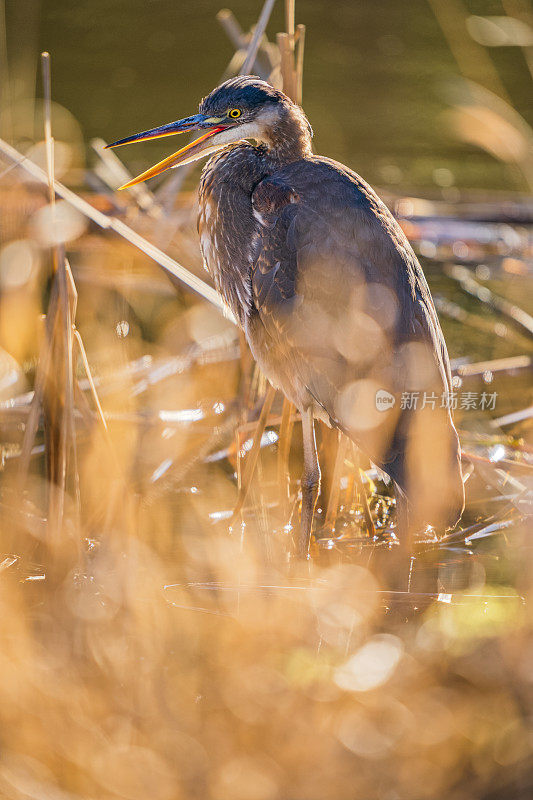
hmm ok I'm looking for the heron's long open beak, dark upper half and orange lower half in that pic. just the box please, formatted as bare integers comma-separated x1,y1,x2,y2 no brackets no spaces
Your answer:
107,114,225,189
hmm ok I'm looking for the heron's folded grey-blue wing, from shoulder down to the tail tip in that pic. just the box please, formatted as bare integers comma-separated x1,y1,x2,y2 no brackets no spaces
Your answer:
249,158,463,524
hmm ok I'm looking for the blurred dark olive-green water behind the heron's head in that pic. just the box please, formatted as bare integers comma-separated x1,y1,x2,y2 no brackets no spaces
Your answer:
6,0,532,190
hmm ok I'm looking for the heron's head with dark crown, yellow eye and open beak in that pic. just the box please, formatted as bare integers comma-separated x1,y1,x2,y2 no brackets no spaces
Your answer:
108,75,313,189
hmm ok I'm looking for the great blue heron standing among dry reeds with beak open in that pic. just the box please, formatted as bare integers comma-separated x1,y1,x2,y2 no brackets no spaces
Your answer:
110,76,464,555
